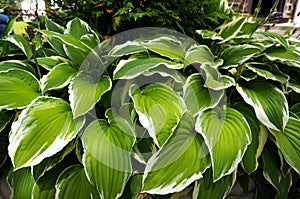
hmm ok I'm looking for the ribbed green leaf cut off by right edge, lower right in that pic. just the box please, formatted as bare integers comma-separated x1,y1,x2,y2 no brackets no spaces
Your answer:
270,117,300,173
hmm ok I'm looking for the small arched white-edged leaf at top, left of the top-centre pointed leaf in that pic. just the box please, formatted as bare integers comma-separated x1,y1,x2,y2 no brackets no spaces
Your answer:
108,41,147,57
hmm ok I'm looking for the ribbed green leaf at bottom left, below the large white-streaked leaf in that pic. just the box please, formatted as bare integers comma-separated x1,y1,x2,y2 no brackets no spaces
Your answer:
8,168,35,198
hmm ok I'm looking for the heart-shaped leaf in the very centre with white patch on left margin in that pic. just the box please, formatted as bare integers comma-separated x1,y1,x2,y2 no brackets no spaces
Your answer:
129,83,186,146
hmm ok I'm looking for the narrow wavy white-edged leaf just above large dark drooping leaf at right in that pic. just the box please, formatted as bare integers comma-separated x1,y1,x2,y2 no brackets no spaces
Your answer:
246,64,289,84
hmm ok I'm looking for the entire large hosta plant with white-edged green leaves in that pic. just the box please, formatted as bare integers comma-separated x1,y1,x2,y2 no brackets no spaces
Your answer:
0,14,300,199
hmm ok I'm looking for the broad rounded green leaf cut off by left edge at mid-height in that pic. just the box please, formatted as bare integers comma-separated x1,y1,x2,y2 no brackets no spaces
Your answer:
0,69,41,109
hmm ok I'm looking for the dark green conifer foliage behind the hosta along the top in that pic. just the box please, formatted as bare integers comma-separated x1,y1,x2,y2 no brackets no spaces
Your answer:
46,0,233,36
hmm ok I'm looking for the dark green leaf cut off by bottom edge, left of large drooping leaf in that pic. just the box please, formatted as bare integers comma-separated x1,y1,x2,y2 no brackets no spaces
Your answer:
55,165,99,198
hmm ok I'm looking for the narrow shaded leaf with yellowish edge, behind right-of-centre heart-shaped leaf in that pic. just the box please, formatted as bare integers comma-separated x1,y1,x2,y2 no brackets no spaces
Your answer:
234,103,268,174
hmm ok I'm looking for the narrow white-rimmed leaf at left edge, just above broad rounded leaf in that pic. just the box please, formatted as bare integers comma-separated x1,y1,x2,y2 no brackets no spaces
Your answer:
0,60,35,74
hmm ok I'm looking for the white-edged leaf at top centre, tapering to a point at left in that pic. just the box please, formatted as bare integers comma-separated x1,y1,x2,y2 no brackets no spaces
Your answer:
141,36,185,62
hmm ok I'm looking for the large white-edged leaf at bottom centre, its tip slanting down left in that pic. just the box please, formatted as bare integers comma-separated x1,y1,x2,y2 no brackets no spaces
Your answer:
143,112,210,194
